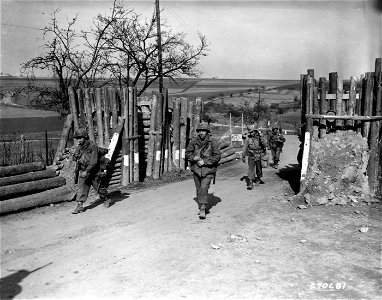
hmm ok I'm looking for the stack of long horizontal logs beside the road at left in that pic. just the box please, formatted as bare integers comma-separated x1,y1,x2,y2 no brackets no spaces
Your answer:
0,162,75,215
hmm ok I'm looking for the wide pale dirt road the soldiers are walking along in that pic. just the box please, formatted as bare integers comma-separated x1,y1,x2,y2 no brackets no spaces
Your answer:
1,136,382,299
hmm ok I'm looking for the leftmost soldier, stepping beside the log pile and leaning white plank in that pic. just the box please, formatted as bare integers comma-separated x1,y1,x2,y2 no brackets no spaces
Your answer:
72,128,111,214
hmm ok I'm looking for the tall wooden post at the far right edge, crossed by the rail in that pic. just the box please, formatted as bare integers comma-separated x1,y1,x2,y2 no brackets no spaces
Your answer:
367,58,382,194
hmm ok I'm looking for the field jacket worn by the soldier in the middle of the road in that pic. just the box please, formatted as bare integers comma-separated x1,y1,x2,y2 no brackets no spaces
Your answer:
186,134,220,177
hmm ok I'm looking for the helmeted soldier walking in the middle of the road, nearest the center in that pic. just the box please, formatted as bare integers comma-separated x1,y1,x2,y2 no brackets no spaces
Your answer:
186,123,220,219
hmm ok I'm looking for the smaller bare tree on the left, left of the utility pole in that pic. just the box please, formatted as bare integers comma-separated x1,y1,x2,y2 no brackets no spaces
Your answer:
21,4,115,109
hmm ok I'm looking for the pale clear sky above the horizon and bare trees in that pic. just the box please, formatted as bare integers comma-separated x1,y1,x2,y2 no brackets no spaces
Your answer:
0,0,382,80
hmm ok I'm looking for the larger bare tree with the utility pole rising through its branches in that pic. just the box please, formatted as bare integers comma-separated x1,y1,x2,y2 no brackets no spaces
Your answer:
95,5,209,95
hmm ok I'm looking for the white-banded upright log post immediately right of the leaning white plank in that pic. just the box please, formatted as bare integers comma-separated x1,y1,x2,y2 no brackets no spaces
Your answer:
122,87,130,186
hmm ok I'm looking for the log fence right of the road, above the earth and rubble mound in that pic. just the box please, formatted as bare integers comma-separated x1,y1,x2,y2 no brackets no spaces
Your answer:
300,58,382,193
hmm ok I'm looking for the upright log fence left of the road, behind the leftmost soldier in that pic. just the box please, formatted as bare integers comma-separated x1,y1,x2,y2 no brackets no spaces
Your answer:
56,87,206,186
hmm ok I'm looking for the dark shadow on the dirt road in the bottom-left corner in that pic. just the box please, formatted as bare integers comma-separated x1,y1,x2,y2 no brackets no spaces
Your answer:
0,263,52,299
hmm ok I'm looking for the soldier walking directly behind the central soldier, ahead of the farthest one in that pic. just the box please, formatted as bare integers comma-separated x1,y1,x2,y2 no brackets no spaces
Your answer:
242,125,267,190
